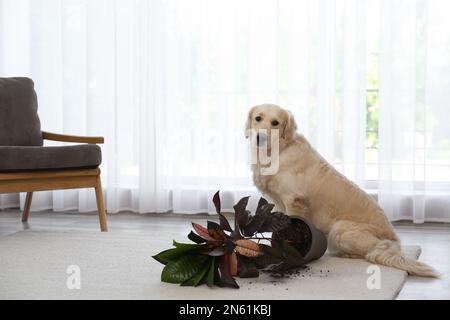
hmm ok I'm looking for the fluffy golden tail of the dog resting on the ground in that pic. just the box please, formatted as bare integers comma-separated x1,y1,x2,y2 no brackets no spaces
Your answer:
365,240,440,278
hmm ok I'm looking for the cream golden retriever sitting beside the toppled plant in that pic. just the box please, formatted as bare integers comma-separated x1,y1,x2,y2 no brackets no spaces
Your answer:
246,104,438,277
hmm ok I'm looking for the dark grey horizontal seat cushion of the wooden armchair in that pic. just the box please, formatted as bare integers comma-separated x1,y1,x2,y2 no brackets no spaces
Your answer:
0,144,102,173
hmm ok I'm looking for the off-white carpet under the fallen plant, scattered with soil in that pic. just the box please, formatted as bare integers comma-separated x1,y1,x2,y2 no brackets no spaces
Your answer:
0,231,420,300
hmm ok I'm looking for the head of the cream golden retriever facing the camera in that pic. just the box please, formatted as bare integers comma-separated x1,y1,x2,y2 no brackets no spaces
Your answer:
245,104,297,147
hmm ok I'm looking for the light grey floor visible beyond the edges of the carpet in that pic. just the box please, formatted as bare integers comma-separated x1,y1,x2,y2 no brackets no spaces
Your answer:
0,210,450,299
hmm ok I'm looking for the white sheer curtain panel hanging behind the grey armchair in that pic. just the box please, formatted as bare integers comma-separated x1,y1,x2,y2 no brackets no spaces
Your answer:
0,0,174,212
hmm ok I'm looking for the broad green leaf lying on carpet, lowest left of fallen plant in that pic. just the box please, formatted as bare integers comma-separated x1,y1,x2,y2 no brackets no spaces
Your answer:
161,254,208,283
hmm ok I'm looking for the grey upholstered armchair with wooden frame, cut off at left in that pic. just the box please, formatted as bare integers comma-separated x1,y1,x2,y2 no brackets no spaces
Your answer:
0,78,108,232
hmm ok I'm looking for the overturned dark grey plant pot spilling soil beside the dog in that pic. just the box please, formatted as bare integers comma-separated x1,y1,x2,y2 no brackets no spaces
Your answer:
272,216,327,263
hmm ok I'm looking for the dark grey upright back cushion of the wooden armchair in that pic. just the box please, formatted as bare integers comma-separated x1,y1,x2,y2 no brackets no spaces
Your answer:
0,78,43,146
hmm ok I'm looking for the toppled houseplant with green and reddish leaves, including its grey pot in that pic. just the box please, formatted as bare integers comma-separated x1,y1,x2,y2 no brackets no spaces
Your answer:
153,192,326,288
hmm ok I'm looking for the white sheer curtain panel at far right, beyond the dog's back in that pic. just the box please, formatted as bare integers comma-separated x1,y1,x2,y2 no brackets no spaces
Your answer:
378,0,450,223
